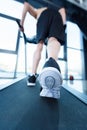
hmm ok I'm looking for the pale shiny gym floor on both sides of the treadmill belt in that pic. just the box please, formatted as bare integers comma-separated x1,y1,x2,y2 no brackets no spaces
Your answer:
0,76,87,104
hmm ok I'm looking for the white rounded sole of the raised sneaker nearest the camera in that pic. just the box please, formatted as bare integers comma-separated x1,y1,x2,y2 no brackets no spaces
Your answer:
38,67,63,99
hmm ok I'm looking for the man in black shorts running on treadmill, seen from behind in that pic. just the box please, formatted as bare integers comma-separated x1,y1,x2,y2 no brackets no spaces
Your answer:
20,0,66,98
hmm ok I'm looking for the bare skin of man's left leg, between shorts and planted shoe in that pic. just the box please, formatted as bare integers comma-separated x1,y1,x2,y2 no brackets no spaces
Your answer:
32,41,43,74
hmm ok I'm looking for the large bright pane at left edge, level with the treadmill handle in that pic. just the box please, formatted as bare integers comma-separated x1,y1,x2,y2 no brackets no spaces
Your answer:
0,17,18,51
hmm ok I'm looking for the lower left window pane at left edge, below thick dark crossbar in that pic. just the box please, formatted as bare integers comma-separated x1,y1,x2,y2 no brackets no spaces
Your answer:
0,53,16,77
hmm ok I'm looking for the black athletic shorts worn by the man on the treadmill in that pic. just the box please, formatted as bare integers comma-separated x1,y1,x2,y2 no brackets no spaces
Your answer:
37,8,66,45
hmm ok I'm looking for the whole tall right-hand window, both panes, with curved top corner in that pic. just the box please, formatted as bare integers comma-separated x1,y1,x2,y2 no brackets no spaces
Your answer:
67,22,84,79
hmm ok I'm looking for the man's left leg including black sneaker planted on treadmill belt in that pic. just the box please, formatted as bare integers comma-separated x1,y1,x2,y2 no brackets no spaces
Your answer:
27,41,43,86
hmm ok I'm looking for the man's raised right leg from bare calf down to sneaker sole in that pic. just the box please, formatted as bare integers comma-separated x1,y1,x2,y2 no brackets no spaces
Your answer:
39,37,62,99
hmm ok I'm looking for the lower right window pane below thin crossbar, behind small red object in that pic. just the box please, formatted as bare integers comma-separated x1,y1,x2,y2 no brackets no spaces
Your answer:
67,49,84,79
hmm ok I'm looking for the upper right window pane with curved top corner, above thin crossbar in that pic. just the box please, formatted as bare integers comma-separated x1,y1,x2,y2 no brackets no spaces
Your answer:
67,22,83,49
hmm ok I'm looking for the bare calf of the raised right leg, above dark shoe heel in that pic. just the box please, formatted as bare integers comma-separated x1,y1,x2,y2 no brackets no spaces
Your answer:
47,37,61,60
